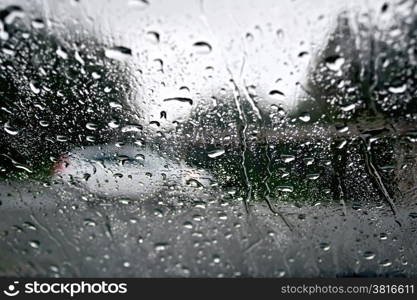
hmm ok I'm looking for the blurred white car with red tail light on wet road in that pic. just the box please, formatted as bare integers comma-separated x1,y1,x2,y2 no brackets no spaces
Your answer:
54,145,213,197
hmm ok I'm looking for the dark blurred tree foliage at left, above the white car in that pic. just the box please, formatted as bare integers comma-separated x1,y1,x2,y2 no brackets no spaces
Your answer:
0,7,129,177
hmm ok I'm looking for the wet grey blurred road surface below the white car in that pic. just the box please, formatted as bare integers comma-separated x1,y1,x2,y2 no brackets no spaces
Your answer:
0,183,417,277
